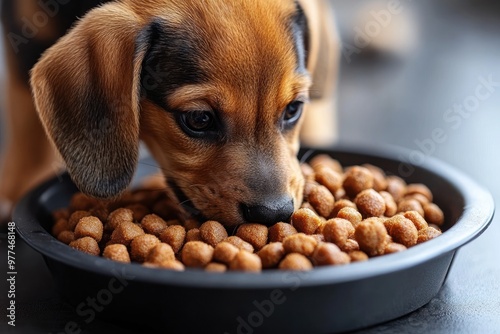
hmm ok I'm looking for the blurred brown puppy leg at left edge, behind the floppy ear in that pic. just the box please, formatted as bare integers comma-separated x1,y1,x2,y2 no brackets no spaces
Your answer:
0,28,62,225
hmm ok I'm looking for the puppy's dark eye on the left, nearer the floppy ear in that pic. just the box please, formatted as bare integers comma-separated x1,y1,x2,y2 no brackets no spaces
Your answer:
179,110,217,138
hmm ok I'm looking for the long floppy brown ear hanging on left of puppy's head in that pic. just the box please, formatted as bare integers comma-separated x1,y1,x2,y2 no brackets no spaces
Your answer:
31,3,148,198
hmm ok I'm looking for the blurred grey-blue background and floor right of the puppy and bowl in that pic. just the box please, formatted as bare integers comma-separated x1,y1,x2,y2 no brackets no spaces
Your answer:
0,0,500,333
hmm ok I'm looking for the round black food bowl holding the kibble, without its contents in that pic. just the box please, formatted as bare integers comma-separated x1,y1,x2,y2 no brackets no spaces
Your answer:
14,149,494,333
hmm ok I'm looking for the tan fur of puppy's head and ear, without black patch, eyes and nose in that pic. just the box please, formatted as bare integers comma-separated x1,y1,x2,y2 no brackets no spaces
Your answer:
0,0,340,226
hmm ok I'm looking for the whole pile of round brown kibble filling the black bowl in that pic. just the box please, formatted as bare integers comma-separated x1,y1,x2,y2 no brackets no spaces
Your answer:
52,155,444,272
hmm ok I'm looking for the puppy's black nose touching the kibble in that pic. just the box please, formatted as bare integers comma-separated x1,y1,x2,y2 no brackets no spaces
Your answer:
241,196,294,226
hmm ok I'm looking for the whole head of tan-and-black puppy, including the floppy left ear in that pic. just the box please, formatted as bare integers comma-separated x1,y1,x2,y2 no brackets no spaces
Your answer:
32,0,310,226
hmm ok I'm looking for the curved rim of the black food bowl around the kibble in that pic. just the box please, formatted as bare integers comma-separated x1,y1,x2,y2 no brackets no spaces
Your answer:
13,145,495,289
